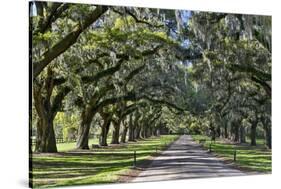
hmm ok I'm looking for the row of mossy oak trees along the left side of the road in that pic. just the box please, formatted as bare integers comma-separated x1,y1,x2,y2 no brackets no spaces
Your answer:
31,2,196,152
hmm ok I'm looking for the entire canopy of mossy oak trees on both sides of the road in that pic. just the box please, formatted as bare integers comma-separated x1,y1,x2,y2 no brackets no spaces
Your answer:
30,2,271,152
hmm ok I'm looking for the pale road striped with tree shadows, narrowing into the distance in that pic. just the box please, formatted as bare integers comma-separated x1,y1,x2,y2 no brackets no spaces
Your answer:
131,135,250,182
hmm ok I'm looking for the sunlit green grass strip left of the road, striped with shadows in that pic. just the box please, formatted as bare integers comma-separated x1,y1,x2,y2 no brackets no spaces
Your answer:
32,135,178,188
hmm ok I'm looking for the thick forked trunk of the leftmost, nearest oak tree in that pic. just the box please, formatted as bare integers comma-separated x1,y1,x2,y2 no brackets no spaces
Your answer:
33,67,70,152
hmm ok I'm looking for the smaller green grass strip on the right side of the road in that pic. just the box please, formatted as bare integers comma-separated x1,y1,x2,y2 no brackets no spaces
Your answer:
192,135,271,172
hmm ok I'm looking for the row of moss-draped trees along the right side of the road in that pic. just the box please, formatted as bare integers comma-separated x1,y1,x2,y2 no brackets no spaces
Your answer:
177,13,271,148
